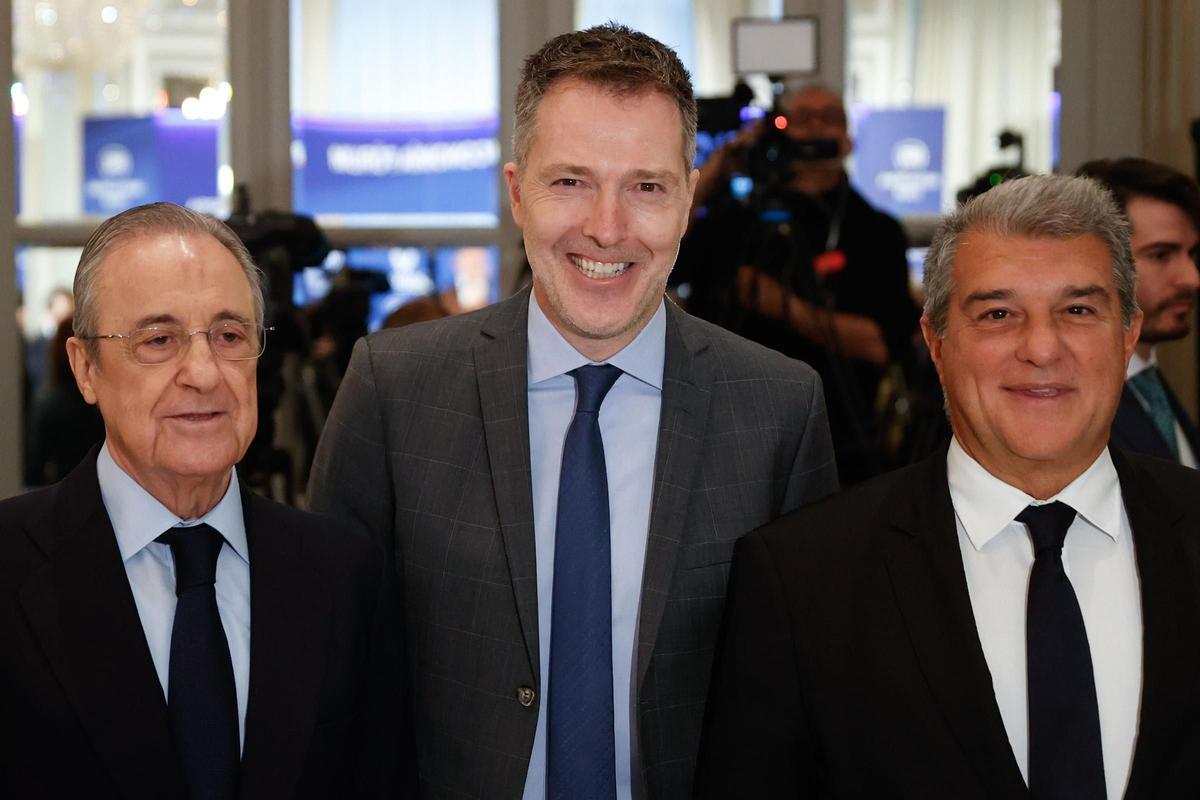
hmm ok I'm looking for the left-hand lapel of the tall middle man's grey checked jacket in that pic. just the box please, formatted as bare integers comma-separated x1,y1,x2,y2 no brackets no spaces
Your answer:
475,289,541,681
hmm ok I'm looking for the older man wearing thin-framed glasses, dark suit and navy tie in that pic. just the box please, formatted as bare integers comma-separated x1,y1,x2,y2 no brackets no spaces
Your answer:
0,203,406,800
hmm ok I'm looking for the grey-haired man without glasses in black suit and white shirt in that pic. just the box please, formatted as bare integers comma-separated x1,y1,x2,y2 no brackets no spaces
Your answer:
697,176,1200,800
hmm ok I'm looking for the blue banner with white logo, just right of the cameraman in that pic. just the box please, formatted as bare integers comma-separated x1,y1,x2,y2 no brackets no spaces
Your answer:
851,108,946,217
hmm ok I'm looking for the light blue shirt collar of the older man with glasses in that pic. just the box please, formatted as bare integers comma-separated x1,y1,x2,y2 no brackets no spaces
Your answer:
96,441,250,564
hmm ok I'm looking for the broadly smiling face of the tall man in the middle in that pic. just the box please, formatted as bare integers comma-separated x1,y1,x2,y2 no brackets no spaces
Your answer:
504,79,697,361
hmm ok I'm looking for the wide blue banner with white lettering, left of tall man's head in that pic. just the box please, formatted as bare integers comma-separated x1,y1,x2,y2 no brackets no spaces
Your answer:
292,116,500,227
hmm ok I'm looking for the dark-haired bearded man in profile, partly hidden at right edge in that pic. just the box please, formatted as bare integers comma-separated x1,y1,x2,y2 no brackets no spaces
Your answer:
1080,158,1200,468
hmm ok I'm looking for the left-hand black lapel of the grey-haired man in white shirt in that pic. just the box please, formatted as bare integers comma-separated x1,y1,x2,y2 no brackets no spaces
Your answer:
881,447,1026,796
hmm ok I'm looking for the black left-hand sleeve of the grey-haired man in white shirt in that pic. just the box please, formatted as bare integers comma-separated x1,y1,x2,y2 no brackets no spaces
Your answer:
696,533,816,800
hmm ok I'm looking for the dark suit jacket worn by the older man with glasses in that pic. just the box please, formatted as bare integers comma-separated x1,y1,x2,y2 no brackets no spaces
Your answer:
0,450,402,800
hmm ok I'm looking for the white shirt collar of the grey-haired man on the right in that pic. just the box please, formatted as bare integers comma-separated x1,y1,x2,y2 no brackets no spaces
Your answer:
946,438,1121,551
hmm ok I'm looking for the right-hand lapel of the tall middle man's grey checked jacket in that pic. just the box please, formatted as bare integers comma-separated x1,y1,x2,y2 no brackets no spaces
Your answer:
635,300,713,686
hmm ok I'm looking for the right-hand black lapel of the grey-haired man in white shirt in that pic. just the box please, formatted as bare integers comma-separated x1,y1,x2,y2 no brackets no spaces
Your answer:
1112,450,1200,798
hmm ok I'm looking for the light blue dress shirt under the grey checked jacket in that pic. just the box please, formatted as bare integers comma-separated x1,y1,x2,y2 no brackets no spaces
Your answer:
524,293,667,800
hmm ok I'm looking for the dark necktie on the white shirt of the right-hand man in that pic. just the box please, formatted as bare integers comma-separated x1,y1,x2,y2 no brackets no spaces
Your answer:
1016,503,1108,800
